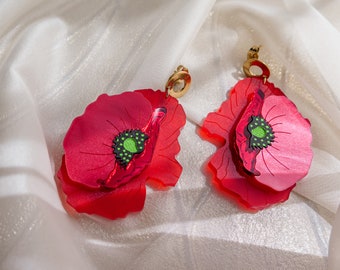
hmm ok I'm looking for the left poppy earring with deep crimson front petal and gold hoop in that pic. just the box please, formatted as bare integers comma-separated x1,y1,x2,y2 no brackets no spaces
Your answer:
57,66,191,219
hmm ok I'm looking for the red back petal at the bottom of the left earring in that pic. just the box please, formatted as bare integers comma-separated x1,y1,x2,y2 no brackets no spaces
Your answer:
57,158,145,219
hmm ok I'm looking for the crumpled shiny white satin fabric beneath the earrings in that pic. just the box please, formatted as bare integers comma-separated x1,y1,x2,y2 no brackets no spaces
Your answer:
0,0,340,269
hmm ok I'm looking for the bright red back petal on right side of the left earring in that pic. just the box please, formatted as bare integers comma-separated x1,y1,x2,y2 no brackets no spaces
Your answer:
138,90,186,186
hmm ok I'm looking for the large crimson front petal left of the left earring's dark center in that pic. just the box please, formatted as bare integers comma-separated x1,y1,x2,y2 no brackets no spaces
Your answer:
64,92,152,188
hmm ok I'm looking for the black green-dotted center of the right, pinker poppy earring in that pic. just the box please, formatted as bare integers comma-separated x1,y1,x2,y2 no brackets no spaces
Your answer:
247,115,275,149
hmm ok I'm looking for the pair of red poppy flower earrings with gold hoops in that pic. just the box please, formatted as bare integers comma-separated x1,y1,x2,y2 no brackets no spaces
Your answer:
57,47,313,219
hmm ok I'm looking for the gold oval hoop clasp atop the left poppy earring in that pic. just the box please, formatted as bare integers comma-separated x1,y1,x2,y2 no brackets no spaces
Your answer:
165,65,191,98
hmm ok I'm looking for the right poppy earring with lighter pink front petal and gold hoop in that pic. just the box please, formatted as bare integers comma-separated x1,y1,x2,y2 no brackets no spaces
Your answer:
200,46,313,210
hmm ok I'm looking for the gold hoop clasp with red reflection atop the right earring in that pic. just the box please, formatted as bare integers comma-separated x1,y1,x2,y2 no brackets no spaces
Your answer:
243,46,270,82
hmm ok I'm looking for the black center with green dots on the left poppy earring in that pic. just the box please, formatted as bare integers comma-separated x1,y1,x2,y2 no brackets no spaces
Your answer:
112,129,149,168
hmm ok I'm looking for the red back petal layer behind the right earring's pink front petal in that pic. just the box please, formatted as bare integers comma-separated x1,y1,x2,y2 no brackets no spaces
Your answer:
201,78,294,210
